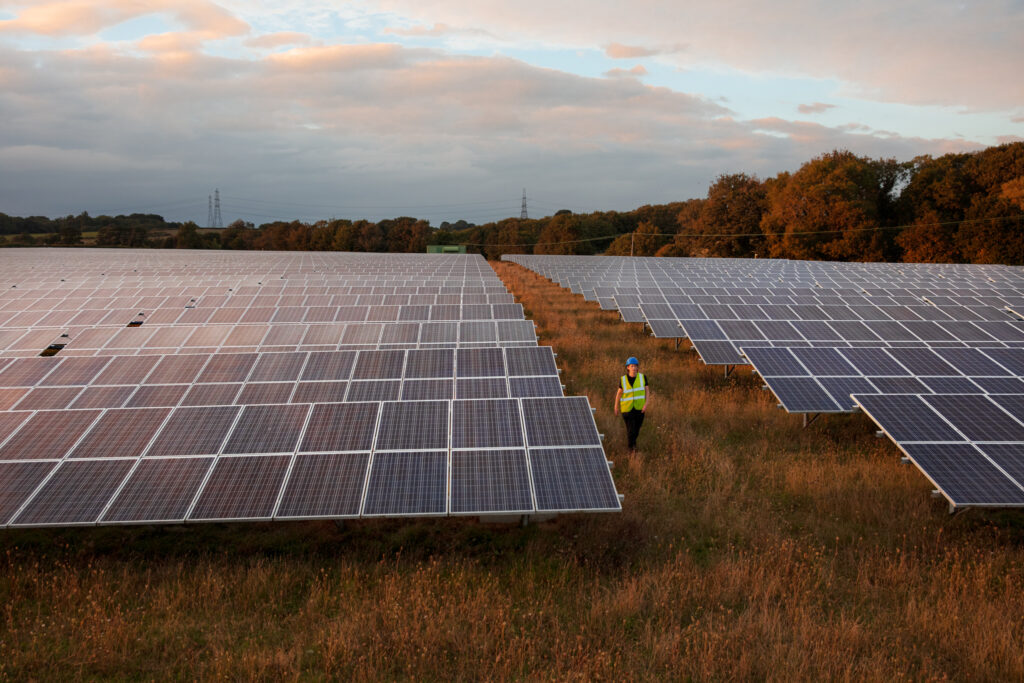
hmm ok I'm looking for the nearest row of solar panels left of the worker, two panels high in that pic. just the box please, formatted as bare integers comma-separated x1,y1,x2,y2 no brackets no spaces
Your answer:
0,397,621,526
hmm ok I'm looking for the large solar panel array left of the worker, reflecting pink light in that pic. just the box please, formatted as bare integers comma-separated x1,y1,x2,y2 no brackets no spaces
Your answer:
0,250,621,527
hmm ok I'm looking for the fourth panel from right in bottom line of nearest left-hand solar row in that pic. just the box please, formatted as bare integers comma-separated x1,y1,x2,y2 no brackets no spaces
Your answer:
276,453,370,518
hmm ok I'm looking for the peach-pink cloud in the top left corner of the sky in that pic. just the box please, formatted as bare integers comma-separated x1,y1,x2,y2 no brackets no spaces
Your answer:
0,0,249,39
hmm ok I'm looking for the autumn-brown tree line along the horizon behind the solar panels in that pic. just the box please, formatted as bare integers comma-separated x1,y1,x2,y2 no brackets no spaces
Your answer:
0,142,1024,265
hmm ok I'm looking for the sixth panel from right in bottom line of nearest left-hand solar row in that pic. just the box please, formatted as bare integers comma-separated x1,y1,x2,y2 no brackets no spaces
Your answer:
102,457,214,522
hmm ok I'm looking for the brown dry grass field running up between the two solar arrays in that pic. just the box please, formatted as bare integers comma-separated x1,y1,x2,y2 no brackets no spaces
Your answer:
0,263,1024,680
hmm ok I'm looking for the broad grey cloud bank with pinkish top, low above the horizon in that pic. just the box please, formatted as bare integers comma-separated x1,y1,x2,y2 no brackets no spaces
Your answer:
0,39,991,224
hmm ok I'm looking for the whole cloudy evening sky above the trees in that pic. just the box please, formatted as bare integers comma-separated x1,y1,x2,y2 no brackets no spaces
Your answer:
0,0,1024,225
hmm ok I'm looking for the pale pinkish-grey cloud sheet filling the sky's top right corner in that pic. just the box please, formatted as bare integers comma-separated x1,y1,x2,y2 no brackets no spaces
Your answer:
373,0,1024,111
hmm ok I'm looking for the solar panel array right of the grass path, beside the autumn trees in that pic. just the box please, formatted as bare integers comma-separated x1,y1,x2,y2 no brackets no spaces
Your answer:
504,255,1024,507
